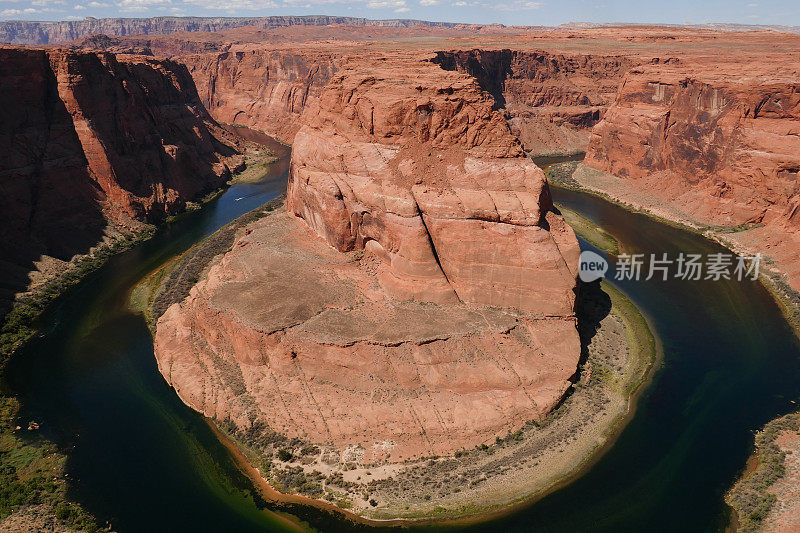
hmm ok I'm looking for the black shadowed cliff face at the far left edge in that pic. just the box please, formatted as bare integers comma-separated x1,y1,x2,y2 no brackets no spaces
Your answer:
0,51,107,320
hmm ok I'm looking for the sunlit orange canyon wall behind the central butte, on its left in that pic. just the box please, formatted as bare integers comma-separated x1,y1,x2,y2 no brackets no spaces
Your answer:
179,46,336,143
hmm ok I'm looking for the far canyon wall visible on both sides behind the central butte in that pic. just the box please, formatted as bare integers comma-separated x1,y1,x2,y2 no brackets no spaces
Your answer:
181,45,643,154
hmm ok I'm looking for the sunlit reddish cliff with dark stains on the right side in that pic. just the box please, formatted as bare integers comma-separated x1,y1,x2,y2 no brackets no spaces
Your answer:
586,61,800,288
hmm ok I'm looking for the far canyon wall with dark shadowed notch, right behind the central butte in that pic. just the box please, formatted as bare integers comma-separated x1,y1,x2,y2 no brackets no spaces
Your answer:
434,49,643,154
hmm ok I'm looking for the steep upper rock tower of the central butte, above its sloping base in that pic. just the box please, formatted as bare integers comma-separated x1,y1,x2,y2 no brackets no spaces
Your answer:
288,52,579,316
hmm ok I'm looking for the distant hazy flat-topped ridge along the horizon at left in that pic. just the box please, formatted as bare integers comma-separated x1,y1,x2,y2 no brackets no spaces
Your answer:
0,15,468,44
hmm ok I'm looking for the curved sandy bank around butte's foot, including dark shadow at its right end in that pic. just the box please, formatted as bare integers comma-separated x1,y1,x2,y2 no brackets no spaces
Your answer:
140,190,657,520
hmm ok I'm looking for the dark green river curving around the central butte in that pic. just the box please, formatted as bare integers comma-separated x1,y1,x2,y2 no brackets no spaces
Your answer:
7,142,800,532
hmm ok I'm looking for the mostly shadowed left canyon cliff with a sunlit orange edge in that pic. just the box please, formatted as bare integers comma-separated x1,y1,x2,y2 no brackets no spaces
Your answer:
0,48,241,314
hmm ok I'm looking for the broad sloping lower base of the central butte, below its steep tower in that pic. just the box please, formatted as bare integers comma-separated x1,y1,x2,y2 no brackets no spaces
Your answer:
155,211,580,463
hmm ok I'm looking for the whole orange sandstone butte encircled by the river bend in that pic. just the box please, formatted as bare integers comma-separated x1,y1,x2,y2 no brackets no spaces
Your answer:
155,55,580,464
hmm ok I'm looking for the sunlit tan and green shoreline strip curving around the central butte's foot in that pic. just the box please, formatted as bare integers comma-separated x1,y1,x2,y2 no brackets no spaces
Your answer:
138,187,660,525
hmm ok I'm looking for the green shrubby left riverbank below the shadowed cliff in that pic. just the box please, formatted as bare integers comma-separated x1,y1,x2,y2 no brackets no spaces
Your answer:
0,133,274,531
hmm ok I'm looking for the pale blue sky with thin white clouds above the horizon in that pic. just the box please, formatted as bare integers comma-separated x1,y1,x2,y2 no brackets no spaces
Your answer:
0,0,800,26
